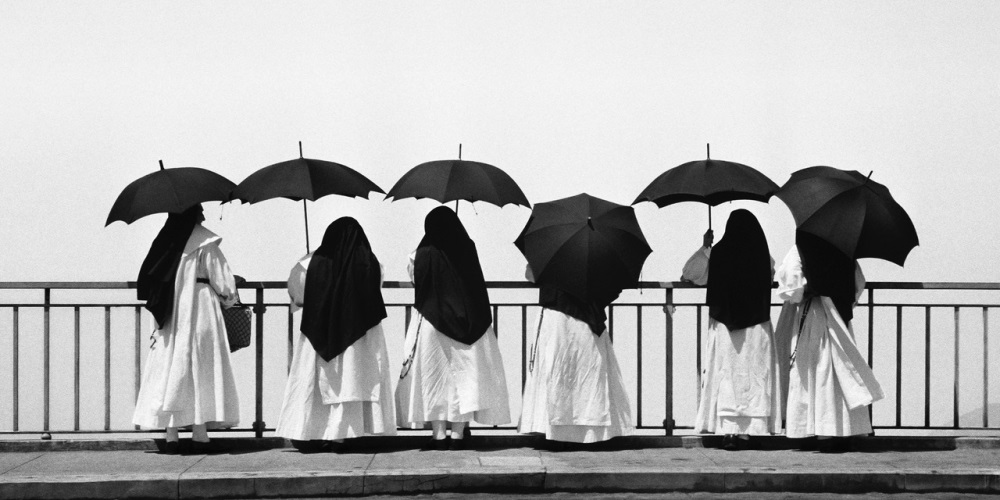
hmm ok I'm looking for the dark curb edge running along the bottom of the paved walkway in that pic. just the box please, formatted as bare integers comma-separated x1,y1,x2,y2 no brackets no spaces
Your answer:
0,469,1000,499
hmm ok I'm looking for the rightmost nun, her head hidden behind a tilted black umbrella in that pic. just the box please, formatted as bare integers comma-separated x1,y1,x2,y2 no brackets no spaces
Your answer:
777,231,884,452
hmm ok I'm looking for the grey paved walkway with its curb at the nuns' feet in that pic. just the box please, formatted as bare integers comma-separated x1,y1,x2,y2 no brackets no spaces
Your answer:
0,437,1000,499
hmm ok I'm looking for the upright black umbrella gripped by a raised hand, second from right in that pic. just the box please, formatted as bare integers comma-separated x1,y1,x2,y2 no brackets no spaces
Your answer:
632,145,778,229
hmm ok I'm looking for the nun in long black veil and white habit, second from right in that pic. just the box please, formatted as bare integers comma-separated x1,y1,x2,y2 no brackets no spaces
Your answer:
694,209,782,450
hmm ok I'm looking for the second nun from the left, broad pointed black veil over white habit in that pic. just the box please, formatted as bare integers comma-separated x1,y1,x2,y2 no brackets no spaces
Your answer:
275,217,396,451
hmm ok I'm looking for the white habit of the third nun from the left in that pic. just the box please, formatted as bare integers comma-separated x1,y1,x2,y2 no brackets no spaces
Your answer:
396,253,510,428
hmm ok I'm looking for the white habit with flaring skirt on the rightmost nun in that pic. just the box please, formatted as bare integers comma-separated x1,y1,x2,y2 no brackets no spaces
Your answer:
776,246,883,438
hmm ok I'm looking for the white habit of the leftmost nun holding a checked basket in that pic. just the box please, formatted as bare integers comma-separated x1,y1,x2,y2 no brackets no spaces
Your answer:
132,224,240,429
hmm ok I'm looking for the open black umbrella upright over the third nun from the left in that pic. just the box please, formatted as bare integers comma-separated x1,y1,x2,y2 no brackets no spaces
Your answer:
386,144,531,208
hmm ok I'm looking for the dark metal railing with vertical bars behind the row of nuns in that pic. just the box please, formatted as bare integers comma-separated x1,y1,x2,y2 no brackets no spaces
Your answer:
0,281,1000,437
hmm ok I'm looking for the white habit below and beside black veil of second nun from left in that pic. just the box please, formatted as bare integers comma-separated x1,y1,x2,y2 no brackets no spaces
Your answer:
275,253,396,441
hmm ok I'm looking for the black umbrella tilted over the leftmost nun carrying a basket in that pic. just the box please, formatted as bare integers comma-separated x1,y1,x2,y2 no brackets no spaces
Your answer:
104,160,236,226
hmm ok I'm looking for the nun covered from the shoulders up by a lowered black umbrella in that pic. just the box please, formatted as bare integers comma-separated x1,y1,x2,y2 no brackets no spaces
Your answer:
518,266,634,443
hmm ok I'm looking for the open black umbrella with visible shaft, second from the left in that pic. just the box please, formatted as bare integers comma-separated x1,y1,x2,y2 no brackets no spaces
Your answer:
231,141,385,252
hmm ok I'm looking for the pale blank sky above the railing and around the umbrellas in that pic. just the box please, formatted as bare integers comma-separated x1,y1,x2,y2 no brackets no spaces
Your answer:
0,1,1000,281
